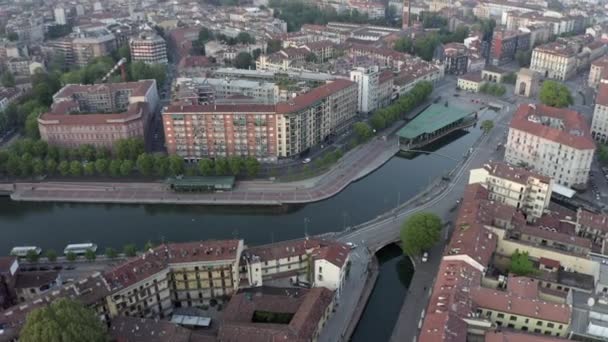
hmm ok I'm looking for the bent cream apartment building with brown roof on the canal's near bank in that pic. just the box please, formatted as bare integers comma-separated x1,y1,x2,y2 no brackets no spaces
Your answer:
103,240,244,318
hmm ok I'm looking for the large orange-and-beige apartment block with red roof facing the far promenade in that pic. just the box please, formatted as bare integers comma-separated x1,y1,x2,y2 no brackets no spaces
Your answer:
162,80,357,162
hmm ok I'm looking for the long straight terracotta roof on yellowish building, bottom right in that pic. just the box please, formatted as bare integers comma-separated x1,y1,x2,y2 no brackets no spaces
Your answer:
470,287,572,324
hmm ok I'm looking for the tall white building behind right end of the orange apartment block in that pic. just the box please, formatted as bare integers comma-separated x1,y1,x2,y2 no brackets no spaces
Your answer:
350,65,380,113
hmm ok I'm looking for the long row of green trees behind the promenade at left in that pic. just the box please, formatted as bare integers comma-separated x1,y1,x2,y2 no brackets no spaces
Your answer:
0,138,260,178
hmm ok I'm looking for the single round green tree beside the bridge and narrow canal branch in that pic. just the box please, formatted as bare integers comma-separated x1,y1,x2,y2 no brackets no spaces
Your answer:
400,212,442,256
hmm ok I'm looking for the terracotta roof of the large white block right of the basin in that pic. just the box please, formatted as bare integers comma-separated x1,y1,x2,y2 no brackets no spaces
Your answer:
510,104,595,150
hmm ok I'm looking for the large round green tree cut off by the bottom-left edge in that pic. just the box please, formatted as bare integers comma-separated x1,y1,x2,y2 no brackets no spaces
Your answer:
19,298,108,342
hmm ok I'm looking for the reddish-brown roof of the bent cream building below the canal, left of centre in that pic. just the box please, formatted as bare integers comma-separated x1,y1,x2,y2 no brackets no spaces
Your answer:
104,240,243,288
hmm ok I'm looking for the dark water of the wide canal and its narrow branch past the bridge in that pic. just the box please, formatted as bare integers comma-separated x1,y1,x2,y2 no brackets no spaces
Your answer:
0,128,481,341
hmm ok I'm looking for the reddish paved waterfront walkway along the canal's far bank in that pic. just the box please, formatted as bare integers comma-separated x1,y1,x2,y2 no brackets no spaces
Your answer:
8,137,399,205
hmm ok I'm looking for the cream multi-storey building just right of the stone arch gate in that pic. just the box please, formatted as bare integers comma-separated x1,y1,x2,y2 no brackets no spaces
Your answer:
530,42,577,81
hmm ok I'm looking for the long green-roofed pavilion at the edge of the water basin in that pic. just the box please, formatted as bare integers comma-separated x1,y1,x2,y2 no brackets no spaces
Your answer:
397,104,477,149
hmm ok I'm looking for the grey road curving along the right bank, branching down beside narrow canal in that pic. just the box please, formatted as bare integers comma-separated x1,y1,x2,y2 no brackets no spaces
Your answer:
328,95,515,341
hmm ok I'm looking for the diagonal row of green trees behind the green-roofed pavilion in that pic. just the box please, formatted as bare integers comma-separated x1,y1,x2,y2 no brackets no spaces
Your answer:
370,81,433,130
